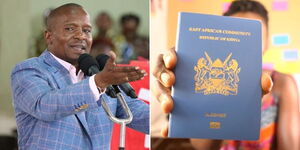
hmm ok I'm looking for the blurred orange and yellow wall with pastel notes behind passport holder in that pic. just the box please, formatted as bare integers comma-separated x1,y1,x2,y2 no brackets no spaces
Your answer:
167,0,300,74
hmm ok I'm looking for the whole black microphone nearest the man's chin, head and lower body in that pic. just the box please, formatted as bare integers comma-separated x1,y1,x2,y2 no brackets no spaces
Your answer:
78,54,117,98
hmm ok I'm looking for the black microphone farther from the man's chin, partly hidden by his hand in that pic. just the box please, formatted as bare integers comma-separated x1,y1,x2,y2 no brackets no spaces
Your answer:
96,54,137,98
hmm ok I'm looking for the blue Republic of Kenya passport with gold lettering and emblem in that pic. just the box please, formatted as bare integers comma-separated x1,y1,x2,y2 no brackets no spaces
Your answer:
169,12,262,140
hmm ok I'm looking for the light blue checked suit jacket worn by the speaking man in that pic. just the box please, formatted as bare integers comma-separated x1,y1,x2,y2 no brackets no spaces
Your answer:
11,50,149,150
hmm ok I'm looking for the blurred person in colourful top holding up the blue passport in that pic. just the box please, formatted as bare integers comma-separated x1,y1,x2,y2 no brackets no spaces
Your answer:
152,0,300,150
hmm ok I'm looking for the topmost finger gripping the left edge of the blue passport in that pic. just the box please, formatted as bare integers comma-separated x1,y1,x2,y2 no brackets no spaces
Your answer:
163,47,177,69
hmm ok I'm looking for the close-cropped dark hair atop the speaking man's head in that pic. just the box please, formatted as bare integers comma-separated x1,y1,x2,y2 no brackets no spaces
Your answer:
46,3,88,30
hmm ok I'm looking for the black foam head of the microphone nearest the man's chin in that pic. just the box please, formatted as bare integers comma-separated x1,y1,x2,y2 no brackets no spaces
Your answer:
78,53,99,75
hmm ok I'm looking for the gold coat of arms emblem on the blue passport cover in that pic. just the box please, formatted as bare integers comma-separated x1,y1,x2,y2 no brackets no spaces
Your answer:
194,52,241,96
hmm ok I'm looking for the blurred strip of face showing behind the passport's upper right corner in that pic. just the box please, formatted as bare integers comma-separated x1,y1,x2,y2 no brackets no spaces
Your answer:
231,12,268,52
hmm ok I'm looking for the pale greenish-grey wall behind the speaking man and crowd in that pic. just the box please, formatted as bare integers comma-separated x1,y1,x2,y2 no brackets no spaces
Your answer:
0,0,149,135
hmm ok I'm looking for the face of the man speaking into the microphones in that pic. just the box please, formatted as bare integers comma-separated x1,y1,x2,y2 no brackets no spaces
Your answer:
45,8,92,66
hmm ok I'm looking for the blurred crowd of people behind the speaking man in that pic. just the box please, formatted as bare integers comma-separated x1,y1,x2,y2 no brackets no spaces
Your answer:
34,9,149,64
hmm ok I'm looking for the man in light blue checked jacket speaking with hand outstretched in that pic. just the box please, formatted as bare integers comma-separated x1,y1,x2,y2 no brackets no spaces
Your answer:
11,3,149,150
